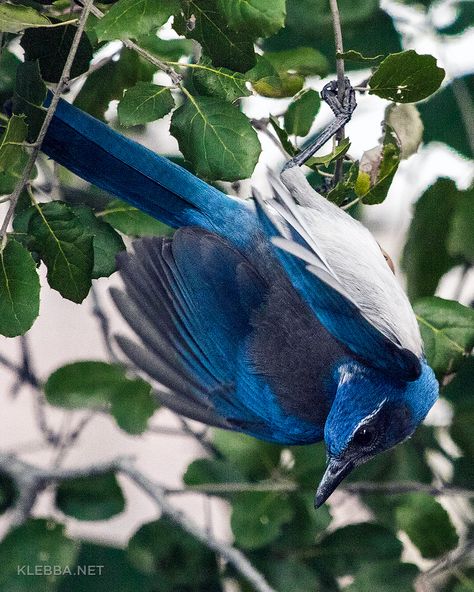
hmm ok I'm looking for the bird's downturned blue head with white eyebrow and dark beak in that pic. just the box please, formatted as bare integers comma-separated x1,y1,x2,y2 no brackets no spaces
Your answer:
315,362,439,507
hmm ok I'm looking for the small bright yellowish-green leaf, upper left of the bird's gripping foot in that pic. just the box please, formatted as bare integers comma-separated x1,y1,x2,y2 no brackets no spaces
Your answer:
264,47,329,77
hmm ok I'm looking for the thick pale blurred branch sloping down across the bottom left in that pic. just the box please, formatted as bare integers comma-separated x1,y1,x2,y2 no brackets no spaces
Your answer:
0,454,275,592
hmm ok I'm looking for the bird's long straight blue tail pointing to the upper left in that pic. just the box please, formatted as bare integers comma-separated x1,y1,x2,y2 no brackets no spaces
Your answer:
42,100,248,235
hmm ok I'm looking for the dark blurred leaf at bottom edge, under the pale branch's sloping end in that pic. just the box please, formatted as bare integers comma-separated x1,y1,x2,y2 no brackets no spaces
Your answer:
127,518,222,592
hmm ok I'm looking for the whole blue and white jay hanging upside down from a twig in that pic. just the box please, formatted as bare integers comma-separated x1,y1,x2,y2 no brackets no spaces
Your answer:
42,81,439,507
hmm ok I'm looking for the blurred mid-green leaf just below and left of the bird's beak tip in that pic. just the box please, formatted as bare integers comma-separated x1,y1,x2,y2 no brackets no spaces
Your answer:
230,492,293,549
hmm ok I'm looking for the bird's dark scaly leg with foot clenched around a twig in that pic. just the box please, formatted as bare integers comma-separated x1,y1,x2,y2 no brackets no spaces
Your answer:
283,78,357,170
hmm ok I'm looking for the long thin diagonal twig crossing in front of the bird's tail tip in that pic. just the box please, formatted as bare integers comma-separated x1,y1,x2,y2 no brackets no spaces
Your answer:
0,0,93,243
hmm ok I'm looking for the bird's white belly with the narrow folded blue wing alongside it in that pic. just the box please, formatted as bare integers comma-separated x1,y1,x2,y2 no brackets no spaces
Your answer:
257,167,423,380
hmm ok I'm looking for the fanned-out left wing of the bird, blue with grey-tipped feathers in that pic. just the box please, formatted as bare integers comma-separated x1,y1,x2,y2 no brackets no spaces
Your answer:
112,227,266,429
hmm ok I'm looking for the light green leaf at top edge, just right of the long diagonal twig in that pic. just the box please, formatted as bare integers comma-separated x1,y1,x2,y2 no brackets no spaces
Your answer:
95,0,179,41
